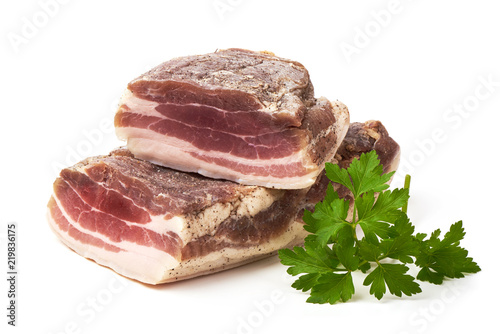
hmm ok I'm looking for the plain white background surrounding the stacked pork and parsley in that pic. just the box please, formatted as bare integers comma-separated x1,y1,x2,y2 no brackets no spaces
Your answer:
0,0,500,334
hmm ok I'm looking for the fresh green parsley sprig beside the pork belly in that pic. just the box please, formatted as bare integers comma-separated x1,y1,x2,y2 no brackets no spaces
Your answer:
279,151,481,304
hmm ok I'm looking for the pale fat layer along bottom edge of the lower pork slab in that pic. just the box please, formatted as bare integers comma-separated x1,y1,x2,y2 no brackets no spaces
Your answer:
47,204,307,284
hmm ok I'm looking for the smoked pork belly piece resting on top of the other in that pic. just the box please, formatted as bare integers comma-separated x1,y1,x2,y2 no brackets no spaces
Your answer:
115,49,349,189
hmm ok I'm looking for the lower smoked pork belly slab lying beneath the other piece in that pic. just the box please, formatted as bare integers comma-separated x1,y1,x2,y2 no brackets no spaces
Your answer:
48,122,399,284
